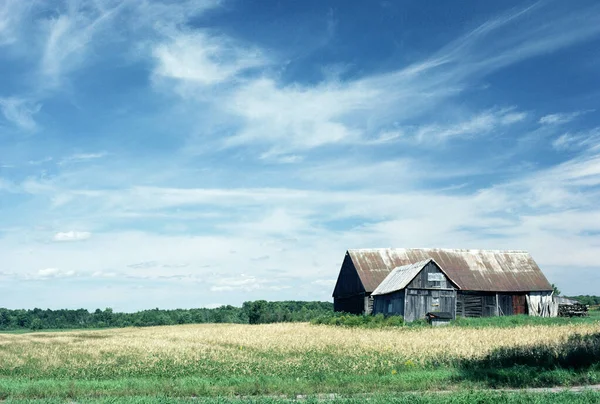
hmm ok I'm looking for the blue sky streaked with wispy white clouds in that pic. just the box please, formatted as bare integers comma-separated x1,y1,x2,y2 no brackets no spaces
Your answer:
0,0,600,311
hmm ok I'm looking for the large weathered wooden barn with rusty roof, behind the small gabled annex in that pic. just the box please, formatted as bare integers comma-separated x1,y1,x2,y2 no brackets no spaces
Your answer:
333,248,555,317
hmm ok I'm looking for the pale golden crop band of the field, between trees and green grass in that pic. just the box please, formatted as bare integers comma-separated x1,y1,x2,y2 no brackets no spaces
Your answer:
0,323,600,378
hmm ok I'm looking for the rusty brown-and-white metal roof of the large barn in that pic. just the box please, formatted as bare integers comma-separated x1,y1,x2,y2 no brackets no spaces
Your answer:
348,248,552,293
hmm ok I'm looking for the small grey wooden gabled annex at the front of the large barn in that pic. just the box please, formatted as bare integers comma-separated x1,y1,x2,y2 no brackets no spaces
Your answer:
371,258,458,321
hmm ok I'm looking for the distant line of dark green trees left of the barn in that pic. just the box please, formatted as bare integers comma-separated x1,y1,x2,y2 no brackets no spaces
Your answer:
0,300,333,330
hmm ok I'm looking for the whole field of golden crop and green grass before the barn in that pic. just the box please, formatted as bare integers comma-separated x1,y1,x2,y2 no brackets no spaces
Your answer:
0,321,600,403
